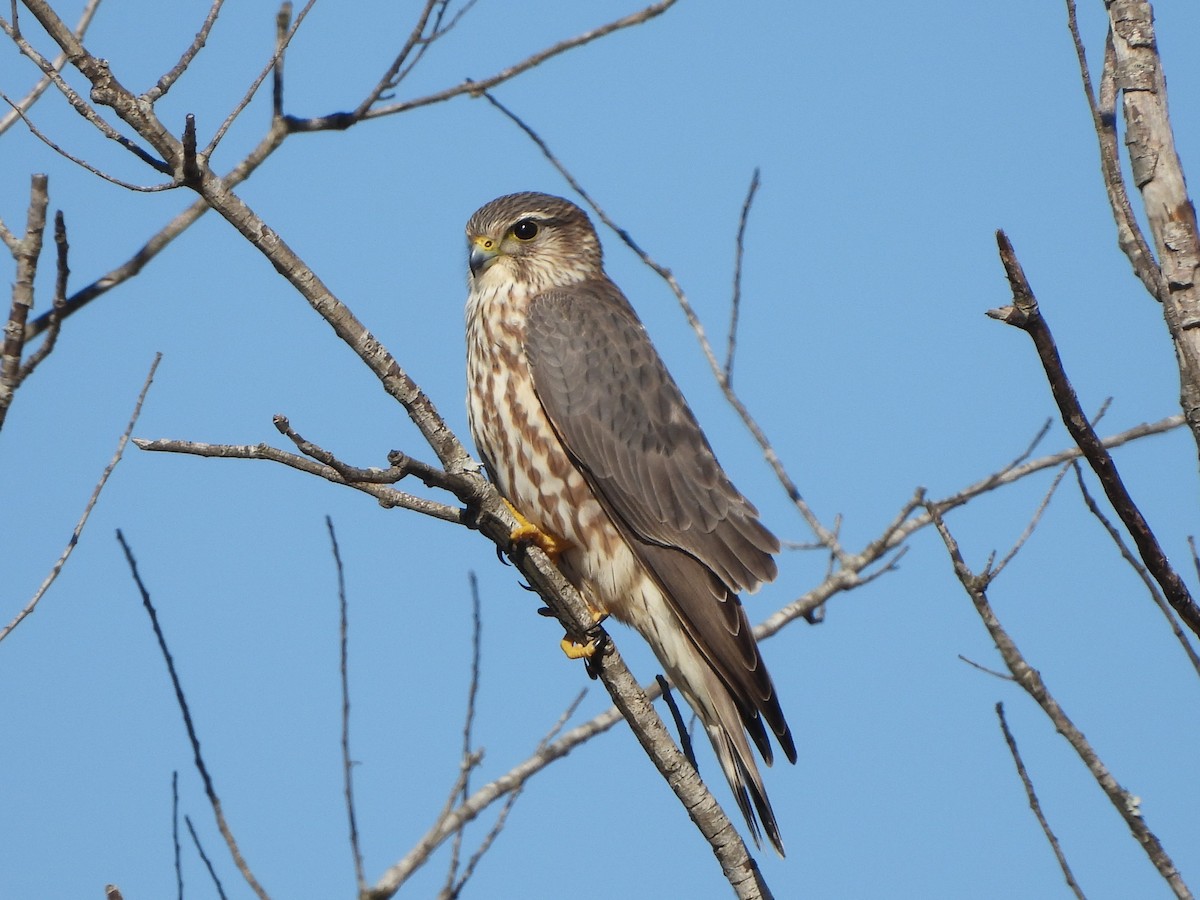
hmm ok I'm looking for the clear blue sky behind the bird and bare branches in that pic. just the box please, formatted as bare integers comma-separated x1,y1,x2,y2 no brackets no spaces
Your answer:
0,0,1200,900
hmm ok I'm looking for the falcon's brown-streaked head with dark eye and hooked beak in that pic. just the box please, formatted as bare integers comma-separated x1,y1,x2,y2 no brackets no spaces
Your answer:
467,192,604,292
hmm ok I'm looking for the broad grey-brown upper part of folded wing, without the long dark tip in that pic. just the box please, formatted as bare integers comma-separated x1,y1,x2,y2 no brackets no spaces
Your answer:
526,281,779,592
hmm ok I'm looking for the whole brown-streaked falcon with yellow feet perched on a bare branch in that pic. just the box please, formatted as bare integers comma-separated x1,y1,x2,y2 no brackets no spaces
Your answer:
467,193,796,854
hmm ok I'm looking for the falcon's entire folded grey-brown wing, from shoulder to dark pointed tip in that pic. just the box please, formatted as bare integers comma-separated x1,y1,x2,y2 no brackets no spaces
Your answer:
526,281,796,762
